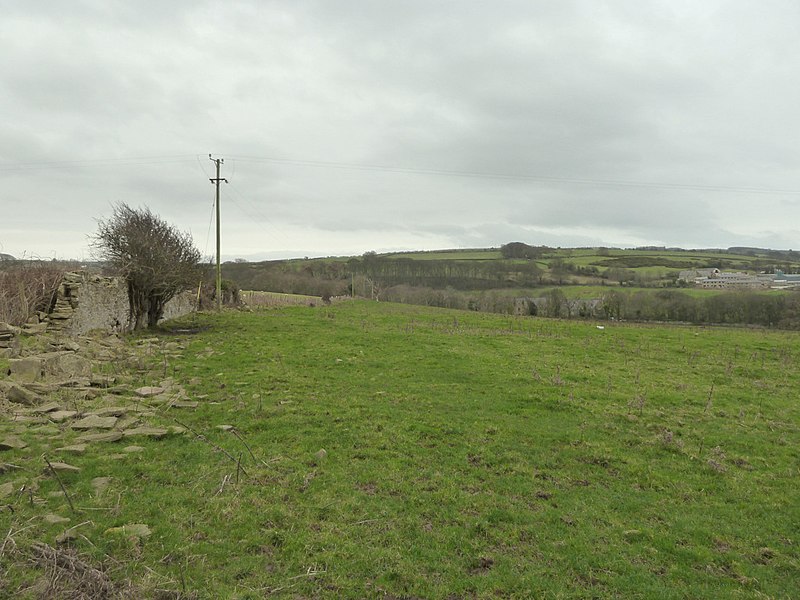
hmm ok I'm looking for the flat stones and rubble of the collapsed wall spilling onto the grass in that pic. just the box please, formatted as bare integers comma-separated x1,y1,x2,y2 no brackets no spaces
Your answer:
0,290,201,568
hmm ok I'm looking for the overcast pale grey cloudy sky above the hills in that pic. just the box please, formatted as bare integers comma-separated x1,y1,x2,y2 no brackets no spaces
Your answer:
0,0,800,259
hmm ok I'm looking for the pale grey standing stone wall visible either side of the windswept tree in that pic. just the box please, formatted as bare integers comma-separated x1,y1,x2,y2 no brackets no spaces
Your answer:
44,272,195,336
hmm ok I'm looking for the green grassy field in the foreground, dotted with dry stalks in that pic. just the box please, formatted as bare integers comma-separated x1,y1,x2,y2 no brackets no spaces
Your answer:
0,301,800,599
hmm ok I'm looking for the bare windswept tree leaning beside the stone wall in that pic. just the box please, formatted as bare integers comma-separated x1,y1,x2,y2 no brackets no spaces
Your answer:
92,203,204,329
